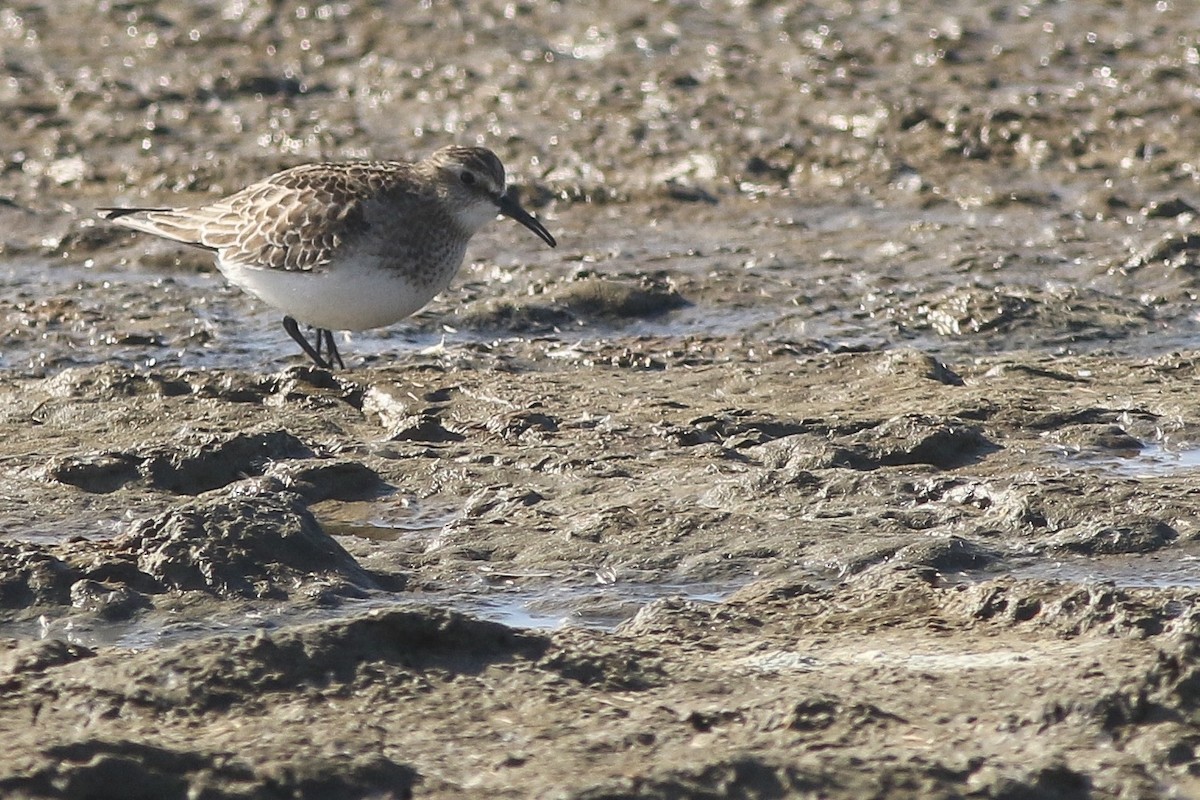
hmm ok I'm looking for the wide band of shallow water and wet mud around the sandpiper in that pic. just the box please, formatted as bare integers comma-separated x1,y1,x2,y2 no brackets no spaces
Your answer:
9,198,1200,374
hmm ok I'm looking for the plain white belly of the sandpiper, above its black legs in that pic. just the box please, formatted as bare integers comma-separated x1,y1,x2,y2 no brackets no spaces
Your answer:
218,257,457,331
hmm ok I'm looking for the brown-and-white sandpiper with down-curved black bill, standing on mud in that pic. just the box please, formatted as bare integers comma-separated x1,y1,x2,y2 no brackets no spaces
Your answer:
98,146,557,369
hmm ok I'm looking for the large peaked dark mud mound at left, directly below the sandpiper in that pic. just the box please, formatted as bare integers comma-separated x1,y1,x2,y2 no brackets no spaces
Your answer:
0,480,388,621
